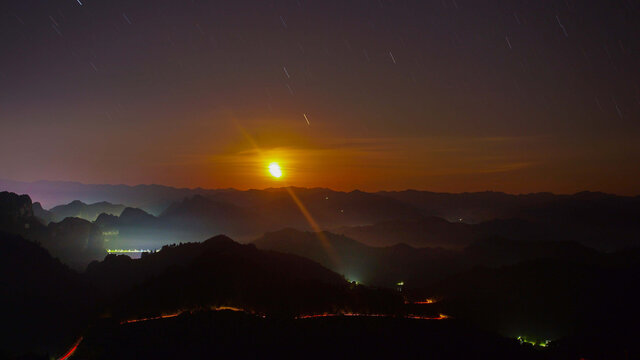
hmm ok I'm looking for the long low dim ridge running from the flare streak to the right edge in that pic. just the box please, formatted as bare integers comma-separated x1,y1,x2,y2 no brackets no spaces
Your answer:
333,214,640,250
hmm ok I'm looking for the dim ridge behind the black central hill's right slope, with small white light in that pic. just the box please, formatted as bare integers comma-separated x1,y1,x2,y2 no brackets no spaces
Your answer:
254,229,599,288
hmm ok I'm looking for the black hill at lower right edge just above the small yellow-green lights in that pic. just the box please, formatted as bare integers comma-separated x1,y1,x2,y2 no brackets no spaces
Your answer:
421,249,640,351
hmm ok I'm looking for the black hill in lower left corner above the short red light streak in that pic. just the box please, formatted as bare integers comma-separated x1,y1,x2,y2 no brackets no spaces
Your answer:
0,232,95,359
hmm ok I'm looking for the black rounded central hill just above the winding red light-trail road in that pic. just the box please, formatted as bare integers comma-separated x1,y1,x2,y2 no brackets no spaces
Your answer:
86,235,402,317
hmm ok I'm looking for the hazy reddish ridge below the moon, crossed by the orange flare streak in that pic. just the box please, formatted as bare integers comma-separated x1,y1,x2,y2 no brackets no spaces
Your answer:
85,189,428,247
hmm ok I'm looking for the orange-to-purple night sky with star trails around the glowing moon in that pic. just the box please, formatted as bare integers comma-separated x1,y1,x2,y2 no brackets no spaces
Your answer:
0,0,640,195
